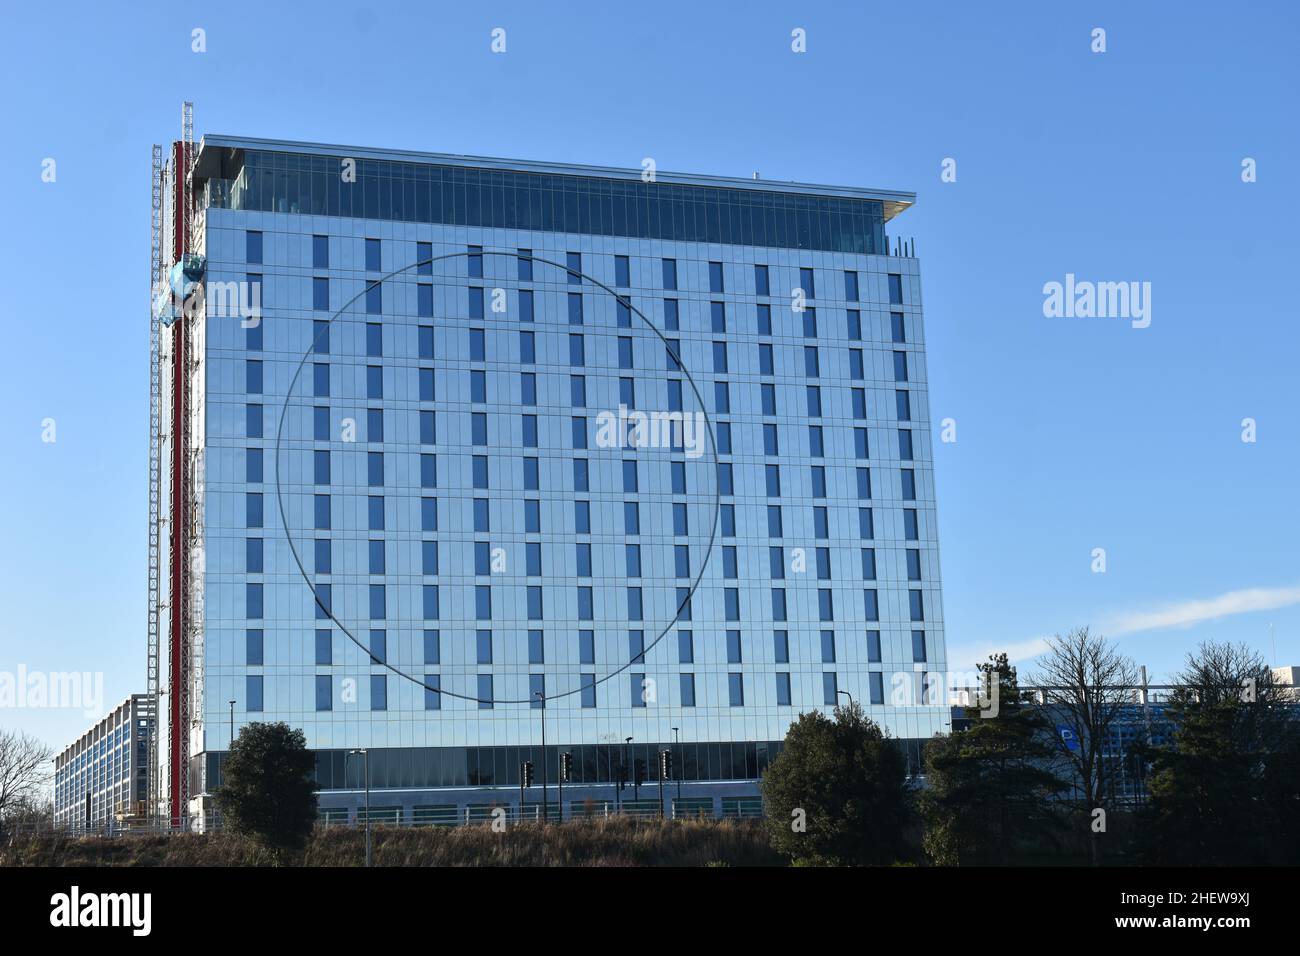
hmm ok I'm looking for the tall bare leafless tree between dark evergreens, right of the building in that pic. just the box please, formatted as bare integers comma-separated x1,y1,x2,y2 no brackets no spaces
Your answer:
1031,627,1138,864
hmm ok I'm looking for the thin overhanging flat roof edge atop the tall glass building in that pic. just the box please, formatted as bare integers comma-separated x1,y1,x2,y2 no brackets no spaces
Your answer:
199,133,917,220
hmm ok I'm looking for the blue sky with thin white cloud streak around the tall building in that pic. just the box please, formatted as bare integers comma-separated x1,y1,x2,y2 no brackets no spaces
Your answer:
0,0,1300,745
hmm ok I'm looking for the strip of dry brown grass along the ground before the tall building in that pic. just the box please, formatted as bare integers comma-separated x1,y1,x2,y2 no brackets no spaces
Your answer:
0,818,784,866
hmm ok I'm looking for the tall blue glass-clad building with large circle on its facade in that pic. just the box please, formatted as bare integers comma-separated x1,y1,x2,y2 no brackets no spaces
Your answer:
172,135,949,822
